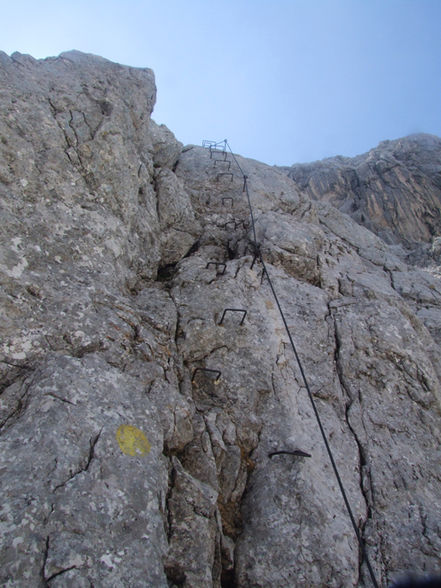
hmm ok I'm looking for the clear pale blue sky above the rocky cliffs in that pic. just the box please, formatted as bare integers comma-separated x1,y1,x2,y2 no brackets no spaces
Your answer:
0,0,441,165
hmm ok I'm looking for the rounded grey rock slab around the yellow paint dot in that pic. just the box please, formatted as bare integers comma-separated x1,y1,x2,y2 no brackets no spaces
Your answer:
1,354,168,586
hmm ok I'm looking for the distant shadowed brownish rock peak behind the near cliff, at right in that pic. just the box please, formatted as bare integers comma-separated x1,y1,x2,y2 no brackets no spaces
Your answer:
283,134,441,255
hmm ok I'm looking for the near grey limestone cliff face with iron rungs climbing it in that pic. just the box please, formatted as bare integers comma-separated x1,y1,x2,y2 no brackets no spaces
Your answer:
0,52,441,587
